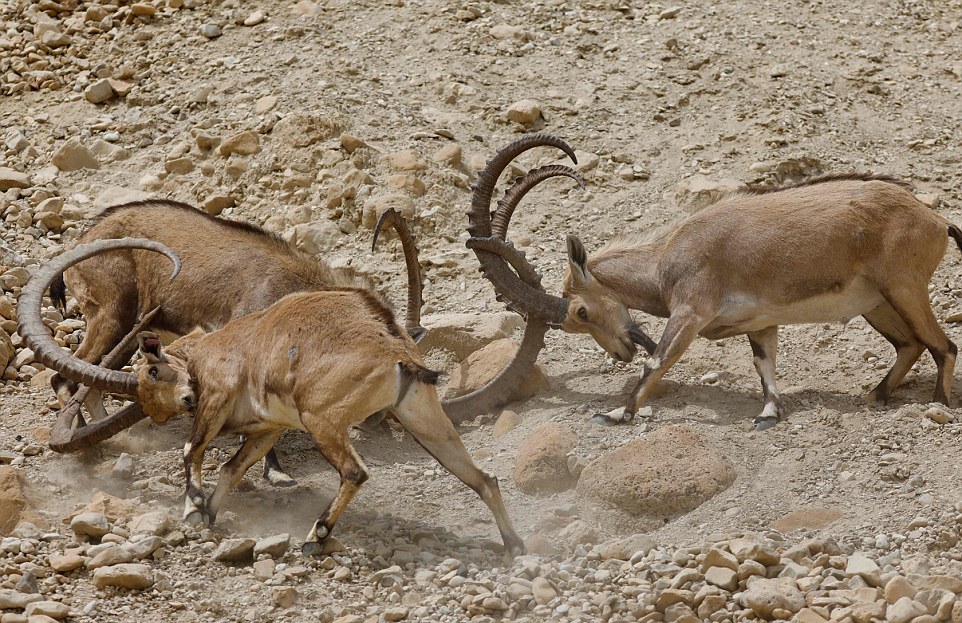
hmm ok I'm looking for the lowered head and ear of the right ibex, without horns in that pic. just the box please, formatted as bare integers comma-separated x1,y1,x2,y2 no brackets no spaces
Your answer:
562,235,641,362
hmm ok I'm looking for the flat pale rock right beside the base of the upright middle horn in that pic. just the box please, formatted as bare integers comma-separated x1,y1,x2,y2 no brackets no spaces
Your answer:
418,312,524,360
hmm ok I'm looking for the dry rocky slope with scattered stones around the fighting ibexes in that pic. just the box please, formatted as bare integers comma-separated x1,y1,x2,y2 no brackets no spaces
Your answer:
0,0,962,623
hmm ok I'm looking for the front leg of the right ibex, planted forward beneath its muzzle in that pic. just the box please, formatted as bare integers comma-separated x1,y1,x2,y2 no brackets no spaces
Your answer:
590,307,709,426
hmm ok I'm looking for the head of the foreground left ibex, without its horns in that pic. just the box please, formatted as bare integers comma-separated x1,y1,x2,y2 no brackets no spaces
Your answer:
134,331,197,423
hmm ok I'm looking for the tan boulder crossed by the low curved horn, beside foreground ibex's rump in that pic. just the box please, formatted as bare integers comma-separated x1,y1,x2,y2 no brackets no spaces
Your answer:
444,339,551,402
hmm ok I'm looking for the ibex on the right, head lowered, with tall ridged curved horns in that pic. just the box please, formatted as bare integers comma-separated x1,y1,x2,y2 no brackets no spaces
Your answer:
468,135,962,430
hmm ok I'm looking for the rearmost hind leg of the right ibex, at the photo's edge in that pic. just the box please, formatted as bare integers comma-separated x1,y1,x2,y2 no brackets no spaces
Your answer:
882,285,958,405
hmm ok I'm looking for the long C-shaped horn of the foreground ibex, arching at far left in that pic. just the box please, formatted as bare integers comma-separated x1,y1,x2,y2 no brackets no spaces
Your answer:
17,238,181,395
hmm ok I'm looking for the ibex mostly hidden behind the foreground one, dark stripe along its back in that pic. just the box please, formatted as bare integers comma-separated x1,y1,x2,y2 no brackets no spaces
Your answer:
20,200,543,483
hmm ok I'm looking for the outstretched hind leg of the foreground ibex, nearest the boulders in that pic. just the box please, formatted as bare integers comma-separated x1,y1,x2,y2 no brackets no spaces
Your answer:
393,383,524,556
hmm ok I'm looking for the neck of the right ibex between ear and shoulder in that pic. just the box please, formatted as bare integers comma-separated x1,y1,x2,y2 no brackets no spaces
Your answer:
588,242,668,318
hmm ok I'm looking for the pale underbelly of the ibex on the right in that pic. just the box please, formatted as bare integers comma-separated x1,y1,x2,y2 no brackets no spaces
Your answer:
701,278,884,339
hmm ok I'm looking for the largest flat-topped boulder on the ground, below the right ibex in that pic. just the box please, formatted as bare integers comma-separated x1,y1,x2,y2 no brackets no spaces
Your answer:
578,426,735,533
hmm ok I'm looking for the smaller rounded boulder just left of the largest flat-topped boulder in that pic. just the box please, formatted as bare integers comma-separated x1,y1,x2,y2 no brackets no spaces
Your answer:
514,422,578,495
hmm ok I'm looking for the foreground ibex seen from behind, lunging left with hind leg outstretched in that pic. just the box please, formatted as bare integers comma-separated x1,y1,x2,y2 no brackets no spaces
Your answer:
22,241,524,555
